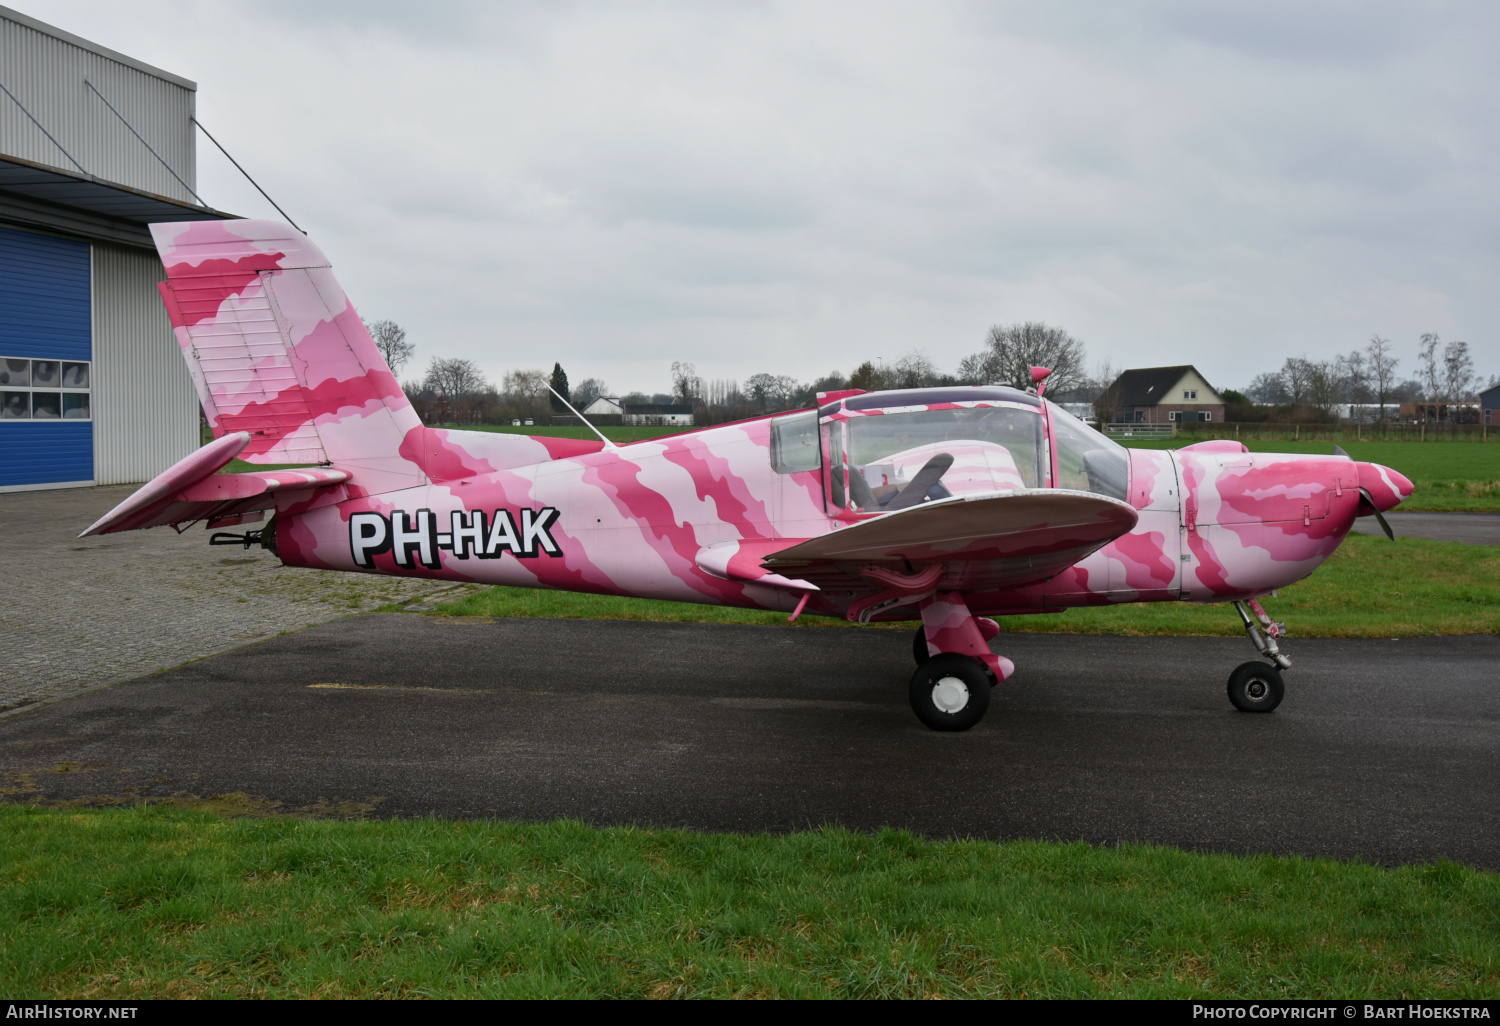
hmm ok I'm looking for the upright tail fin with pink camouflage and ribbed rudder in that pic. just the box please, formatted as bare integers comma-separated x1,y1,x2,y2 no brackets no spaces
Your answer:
152,221,422,492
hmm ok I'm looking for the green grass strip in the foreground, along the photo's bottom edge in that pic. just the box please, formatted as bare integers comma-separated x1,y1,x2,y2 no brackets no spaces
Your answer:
0,806,1500,999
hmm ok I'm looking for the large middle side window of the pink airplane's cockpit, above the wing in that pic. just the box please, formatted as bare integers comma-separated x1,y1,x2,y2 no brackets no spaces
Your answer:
827,405,1046,513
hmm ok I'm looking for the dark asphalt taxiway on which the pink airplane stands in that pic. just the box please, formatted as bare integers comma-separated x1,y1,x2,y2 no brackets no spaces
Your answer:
0,615,1500,869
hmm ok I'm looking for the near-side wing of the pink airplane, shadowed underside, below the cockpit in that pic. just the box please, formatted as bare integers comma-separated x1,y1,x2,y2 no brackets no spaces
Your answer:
762,488,1139,588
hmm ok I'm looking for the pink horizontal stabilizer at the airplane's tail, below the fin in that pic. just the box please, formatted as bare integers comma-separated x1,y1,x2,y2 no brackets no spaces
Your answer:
78,432,350,537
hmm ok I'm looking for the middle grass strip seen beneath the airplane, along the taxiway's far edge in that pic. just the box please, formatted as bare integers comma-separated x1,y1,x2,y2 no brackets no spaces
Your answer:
435,534,1500,639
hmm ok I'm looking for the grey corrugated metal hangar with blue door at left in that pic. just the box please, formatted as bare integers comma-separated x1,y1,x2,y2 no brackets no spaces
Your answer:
0,8,231,491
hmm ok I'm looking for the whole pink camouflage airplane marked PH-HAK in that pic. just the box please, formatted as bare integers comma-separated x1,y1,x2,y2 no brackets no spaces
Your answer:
83,221,1412,731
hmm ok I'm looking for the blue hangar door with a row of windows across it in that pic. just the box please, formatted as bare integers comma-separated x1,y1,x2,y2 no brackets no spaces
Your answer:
0,228,93,491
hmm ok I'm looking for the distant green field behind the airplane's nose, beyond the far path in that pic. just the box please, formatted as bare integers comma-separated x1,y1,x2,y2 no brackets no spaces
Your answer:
1118,434,1500,513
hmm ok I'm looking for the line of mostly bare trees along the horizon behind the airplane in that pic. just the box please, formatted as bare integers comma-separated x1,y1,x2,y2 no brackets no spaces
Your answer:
368,312,1500,425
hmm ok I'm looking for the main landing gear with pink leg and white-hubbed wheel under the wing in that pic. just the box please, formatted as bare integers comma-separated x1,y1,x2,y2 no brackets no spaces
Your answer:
909,593,1016,731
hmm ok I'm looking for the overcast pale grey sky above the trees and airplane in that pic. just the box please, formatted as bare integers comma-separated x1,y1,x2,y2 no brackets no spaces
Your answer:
8,0,1500,392
